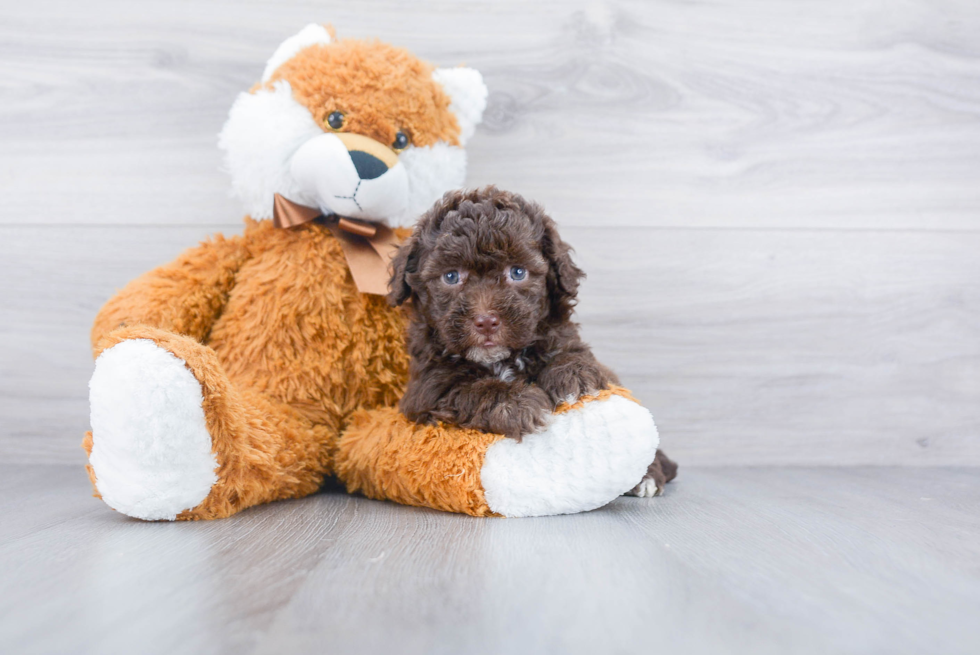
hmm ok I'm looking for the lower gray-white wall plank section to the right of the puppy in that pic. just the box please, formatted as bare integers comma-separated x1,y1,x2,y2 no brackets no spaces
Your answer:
566,229,980,465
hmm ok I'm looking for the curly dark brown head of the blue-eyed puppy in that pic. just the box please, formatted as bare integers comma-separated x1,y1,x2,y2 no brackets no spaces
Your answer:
388,186,584,364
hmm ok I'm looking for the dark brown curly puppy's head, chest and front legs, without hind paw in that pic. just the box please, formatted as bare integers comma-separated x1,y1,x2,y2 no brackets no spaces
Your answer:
389,186,617,437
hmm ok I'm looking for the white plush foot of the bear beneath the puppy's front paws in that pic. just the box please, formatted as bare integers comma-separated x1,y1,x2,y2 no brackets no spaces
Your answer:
480,396,660,517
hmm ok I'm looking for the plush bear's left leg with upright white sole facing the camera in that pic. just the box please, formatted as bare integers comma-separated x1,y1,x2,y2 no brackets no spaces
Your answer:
83,326,332,520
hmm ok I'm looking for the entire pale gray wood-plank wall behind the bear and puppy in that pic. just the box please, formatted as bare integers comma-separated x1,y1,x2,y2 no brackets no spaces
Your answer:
0,0,980,465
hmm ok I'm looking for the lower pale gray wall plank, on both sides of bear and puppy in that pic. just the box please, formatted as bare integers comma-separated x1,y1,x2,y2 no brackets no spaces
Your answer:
0,226,980,466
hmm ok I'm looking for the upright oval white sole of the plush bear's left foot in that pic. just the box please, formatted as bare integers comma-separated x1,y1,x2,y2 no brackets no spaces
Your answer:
89,339,218,521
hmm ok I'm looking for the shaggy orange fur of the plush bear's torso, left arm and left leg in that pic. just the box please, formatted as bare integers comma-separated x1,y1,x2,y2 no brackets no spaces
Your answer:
85,221,408,519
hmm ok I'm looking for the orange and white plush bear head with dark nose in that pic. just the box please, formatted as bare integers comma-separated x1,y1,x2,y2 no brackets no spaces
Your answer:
219,25,487,226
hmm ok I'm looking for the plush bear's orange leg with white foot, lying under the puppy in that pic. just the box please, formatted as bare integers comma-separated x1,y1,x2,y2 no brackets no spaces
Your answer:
333,387,659,517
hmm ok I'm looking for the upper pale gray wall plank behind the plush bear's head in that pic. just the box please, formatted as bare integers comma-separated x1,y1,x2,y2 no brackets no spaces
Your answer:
0,0,980,230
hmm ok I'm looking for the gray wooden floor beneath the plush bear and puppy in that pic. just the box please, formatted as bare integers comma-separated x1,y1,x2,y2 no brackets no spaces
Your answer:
0,465,980,655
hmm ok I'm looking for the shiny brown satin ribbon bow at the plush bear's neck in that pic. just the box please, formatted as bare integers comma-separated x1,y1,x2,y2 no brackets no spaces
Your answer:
272,193,400,296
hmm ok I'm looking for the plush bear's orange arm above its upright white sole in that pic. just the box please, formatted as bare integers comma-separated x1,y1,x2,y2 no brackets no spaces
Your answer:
91,235,250,357
